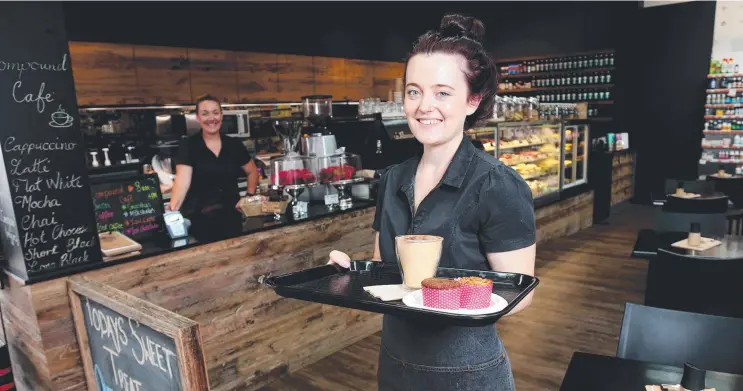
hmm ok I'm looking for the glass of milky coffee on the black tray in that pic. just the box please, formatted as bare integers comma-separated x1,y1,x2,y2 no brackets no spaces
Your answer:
395,235,444,289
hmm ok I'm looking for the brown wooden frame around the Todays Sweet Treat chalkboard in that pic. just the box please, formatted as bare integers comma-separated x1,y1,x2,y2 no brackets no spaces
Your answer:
67,276,209,391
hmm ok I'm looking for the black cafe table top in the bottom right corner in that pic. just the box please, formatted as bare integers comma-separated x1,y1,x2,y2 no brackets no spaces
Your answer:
560,352,743,391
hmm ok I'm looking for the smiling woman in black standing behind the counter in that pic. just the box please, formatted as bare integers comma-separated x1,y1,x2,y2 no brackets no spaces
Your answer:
170,95,259,234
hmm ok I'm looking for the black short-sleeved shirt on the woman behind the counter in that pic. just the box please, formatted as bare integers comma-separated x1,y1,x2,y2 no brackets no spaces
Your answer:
175,132,251,215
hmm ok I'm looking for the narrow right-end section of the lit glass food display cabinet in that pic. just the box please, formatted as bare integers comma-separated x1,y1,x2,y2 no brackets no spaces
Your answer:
562,125,590,189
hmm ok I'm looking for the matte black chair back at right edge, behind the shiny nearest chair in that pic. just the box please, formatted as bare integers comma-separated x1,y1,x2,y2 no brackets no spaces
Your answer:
645,248,743,319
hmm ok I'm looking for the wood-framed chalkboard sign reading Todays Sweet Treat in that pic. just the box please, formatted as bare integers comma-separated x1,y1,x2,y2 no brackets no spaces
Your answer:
68,277,209,391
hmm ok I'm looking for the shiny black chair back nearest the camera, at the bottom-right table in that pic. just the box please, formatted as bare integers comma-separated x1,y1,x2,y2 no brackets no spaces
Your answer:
617,303,743,374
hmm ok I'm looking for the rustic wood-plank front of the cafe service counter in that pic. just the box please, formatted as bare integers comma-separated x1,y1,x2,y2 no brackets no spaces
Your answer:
0,192,593,391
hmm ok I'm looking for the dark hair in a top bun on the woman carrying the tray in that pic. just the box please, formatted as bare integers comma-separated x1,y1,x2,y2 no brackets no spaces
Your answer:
405,14,496,130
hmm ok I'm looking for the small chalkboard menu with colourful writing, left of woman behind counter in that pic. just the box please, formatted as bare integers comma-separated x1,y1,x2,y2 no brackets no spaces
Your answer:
91,175,165,239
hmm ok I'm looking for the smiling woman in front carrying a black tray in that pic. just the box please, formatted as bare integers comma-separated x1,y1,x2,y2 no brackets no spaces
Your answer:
330,15,536,391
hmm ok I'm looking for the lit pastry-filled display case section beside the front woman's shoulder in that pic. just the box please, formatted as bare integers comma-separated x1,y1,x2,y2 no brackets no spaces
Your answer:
497,122,562,198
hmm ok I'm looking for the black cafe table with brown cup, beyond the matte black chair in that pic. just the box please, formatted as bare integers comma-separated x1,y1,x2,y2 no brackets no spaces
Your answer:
632,229,743,259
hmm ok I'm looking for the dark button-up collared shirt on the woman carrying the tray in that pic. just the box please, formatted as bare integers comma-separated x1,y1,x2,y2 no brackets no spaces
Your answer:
372,137,536,270
